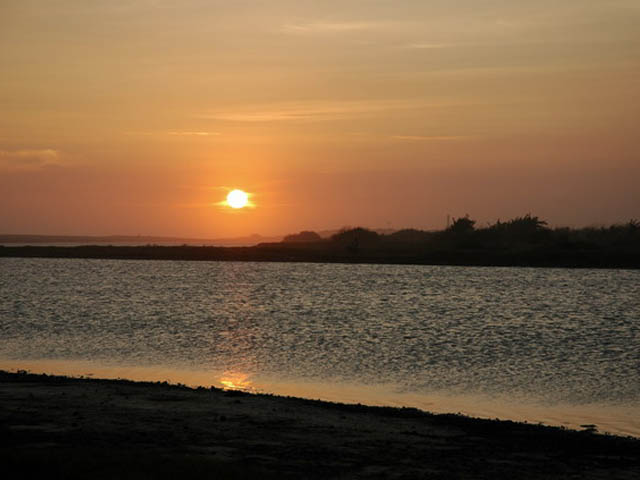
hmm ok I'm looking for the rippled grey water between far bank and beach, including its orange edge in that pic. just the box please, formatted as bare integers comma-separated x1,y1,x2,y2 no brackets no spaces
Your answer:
0,259,640,436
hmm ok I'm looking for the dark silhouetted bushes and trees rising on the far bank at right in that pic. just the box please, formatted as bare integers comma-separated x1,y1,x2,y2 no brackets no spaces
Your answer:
283,214,640,268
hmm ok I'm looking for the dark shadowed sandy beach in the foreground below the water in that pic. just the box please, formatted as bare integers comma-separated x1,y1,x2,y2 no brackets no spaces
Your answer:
0,371,640,479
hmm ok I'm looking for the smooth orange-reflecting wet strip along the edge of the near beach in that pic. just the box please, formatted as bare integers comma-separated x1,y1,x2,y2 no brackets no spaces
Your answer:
0,358,640,437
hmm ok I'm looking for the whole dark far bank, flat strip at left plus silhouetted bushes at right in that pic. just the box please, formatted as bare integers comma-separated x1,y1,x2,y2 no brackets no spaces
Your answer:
0,214,640,268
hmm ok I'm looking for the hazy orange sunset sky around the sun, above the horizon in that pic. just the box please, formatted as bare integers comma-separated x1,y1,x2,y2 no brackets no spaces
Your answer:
0,0,640,238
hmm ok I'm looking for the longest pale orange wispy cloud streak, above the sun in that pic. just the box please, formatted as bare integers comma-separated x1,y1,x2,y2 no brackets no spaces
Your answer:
198,100,456,122
